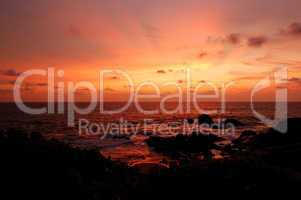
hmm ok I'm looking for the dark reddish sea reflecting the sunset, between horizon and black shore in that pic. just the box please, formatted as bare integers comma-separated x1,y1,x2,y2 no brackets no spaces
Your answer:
0,102,301,165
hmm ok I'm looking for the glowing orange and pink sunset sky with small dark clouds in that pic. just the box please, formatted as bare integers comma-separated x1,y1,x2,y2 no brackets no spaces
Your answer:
0,0,301,101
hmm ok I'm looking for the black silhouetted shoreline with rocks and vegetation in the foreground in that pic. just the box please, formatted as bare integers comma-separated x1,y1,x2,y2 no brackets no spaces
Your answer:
0,119,301,200
